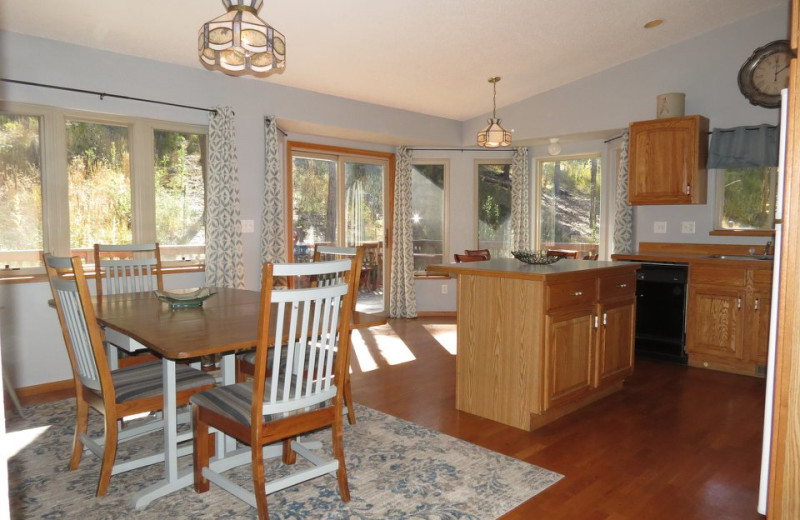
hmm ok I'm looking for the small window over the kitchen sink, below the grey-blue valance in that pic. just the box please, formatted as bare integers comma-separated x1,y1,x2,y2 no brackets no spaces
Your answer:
716,166,778,230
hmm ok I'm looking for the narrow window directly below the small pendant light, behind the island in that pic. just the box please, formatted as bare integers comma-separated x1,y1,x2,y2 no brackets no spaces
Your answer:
476,161,511,258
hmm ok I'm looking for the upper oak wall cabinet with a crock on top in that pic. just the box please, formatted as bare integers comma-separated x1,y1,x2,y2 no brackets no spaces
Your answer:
628,115,708,204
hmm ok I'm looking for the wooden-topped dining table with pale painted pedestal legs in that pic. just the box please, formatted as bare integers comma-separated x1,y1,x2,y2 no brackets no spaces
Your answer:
95,287,386,508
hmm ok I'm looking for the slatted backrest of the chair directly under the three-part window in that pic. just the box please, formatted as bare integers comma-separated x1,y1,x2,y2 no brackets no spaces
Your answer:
94,243,164,294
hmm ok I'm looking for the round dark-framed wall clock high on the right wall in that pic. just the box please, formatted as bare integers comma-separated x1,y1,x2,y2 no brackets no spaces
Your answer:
739,40,794,108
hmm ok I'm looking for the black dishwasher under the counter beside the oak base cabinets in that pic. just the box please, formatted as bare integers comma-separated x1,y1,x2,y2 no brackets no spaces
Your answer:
635,263,688,364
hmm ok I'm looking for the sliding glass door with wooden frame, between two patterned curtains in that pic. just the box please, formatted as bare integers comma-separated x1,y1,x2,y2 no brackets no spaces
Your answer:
291,145,389,312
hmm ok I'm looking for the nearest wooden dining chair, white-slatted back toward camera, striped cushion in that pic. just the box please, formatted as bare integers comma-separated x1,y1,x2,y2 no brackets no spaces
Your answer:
191,259,354,519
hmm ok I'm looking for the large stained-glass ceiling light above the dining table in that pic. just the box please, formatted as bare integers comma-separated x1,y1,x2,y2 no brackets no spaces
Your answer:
198,0,286,75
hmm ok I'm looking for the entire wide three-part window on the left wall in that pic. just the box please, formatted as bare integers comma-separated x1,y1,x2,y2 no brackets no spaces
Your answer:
0,103,206,268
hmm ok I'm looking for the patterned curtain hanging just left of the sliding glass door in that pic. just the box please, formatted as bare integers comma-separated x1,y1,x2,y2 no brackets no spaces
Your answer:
259,117,287,264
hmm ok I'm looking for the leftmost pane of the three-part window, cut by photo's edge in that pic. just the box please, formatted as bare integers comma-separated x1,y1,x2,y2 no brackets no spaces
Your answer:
0,114,42,267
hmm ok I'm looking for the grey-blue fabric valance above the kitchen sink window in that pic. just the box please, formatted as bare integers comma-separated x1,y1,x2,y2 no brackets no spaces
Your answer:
706,125,779,168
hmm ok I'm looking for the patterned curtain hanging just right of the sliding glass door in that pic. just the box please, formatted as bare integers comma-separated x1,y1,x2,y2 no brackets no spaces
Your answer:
389,146,417,318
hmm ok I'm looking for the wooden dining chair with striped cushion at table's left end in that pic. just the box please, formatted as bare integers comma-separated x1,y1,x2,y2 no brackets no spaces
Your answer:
44,254,214,496
